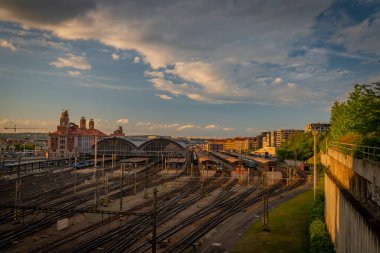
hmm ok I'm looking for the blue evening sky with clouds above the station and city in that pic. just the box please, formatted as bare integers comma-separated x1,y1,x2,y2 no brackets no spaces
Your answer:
0,0,380,137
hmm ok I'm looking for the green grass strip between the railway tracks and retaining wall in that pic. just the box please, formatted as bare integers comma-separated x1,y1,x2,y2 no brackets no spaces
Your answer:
233,179,324,253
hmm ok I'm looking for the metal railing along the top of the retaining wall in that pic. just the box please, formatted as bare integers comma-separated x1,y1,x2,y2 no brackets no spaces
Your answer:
328,141,380,161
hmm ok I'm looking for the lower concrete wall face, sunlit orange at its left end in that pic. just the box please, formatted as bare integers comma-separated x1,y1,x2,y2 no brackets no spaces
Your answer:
325,174,380,253
